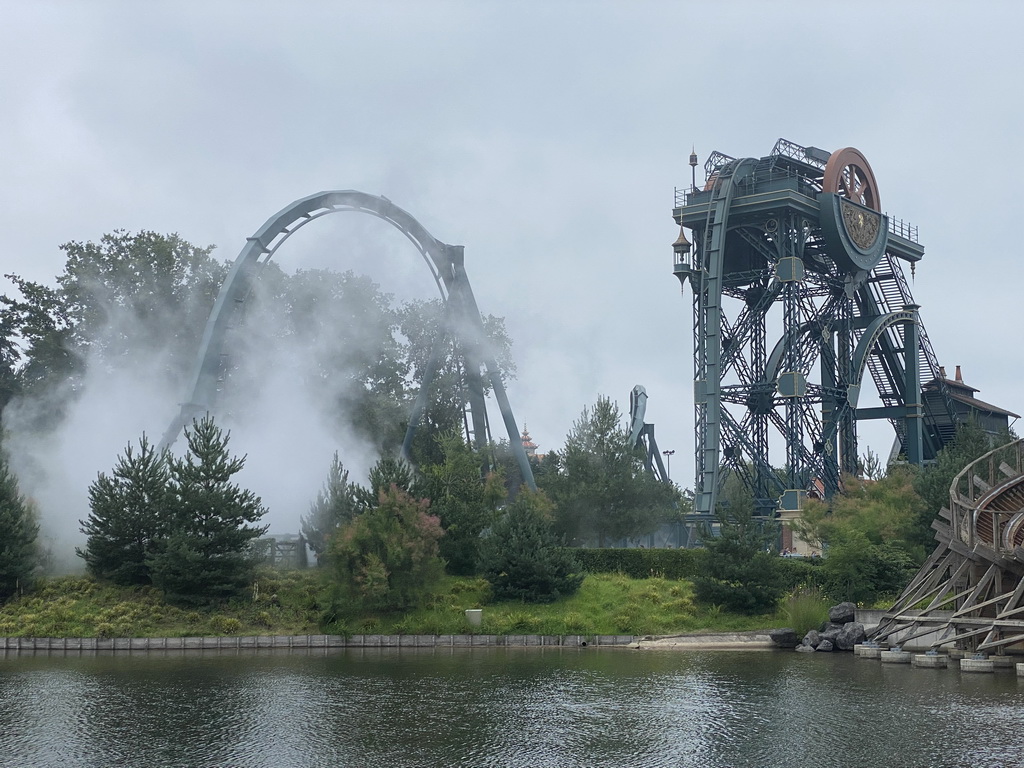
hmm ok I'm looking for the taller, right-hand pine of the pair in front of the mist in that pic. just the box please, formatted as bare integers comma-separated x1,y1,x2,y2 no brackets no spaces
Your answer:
147,416,266,601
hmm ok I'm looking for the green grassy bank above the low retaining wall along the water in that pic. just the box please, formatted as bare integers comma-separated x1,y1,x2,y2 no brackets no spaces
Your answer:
0,569,788,637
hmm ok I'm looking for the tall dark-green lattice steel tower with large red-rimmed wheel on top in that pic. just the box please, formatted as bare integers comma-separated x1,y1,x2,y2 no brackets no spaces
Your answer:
673,139,955,515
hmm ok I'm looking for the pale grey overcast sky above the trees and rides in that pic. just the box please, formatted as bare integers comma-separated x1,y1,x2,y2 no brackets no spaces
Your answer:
0,0,1024,524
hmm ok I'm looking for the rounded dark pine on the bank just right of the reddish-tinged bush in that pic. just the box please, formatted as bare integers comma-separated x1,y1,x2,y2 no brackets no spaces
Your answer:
479,489,583,602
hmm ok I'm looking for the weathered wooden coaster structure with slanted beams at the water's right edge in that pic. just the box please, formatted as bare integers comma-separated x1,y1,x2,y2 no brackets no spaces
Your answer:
870,440,1024,653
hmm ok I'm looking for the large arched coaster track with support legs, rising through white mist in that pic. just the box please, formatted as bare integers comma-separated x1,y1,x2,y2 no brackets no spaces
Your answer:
160,189,537,489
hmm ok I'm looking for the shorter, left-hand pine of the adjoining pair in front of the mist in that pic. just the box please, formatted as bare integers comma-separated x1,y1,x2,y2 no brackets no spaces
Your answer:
76,434,171,585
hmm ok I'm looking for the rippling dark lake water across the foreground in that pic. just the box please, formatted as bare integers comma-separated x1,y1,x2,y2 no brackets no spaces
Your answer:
0,648,1024,768
